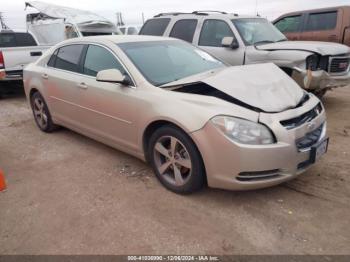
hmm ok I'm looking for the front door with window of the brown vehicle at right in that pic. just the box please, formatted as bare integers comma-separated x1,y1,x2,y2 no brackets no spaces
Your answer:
274,14,304,41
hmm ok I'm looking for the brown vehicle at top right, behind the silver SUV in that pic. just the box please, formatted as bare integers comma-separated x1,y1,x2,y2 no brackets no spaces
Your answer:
273,6,350,46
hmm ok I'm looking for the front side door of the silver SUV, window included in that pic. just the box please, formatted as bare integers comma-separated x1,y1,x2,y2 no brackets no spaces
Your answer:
194,19,245,65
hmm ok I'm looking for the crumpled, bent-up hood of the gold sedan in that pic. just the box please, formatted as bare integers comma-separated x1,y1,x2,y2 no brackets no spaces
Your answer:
200,63,304,112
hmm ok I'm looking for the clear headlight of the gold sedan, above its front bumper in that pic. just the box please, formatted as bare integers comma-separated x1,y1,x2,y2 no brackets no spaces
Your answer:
211,116,275,145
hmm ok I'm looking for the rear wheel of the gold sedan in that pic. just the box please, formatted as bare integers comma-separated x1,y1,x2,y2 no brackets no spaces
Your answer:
30,92,58,133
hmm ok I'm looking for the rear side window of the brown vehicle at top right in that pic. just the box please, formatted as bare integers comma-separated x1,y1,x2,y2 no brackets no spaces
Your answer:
305,11,338,31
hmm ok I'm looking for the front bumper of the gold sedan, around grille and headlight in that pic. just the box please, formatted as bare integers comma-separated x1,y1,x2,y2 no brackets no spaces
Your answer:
191,94,326,190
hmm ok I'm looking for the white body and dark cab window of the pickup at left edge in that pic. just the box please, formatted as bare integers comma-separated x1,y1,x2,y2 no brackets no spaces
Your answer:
0,33,46,72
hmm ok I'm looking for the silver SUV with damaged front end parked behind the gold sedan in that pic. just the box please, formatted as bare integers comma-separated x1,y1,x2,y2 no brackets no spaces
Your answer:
140,11,350,97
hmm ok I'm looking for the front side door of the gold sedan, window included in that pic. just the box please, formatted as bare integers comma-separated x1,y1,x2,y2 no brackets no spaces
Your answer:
80,44,139,151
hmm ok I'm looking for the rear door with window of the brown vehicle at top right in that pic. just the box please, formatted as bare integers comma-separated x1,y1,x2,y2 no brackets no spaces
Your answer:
300,9,343,43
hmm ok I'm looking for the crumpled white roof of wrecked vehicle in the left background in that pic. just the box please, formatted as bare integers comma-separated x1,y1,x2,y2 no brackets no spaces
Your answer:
25,1,114,25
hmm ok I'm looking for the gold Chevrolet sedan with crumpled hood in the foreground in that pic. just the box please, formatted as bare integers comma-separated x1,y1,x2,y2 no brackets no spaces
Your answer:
24,36,328,194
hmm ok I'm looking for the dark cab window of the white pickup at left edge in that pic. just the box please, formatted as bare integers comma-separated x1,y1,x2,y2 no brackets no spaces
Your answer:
0,33,37,47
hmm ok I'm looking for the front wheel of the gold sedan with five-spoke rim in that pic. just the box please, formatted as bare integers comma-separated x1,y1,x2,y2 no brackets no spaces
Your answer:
147,125,205,194
